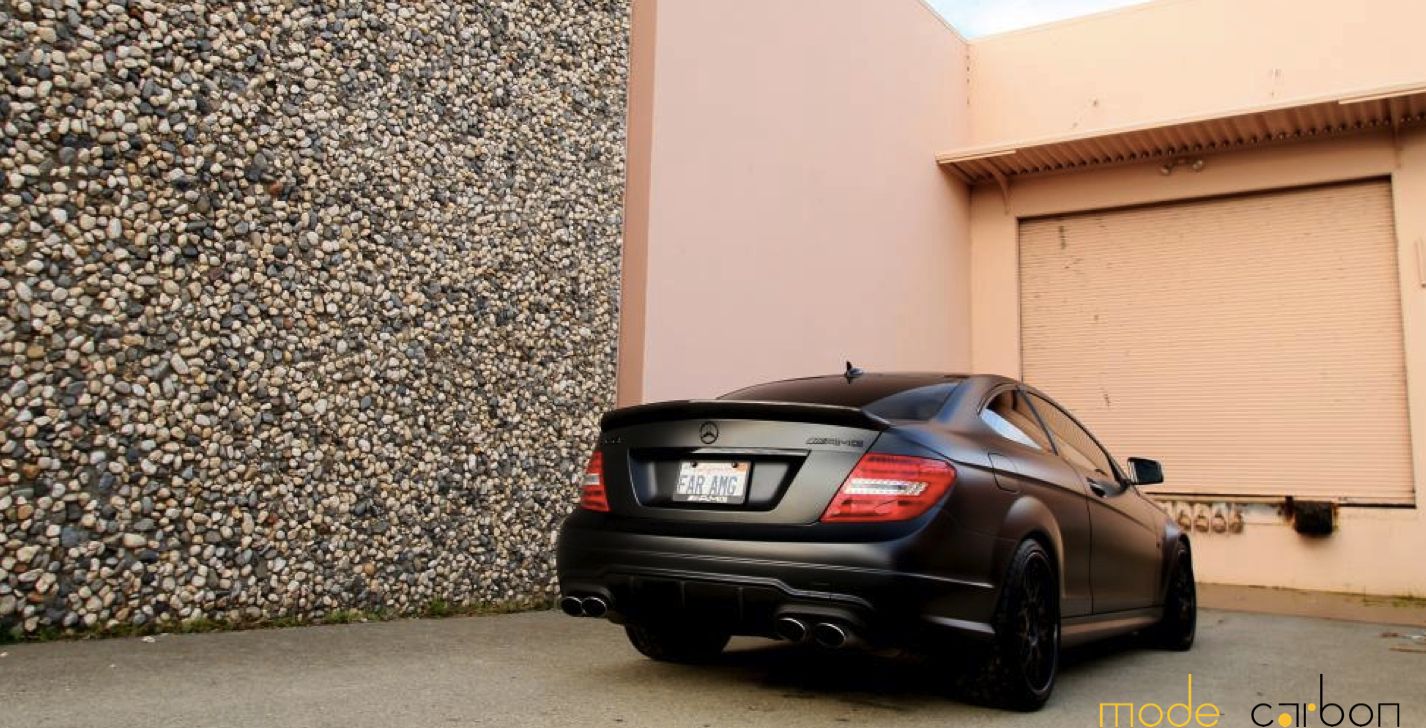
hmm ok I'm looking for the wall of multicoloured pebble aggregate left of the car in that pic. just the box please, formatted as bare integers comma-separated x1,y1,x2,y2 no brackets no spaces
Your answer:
0,0,627,635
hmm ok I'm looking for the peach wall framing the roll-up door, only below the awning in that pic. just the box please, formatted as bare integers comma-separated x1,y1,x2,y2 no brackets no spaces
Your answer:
971,130,1426,596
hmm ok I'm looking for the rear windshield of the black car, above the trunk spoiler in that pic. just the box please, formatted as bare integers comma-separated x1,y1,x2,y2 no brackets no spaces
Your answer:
720,375,961,420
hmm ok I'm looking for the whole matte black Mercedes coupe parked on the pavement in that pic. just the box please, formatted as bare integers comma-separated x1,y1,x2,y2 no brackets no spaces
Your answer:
558,373,1196,709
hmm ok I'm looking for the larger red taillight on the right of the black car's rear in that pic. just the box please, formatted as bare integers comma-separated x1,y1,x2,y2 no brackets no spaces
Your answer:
821,453,955,523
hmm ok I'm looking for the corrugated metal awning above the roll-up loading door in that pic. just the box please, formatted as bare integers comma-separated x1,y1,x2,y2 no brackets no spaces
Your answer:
935,83,1426,184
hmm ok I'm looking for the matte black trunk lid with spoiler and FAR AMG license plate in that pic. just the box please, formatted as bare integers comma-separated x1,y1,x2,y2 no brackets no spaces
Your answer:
600,400,890,524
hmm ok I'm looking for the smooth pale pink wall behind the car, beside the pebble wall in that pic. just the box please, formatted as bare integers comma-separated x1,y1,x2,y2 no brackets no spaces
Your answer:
633,0,970,403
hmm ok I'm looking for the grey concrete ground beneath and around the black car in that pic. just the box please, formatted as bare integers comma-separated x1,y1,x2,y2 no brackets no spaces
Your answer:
0,611,1426,728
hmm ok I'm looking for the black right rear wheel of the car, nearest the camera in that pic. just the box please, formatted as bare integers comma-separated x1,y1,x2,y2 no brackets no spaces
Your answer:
968,541,1060,711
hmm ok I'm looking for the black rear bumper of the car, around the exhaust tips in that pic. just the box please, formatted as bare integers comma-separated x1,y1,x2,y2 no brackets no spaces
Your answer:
558,521,995,645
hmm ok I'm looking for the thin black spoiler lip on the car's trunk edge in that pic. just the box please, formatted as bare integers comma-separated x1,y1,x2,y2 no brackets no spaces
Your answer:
599,399,891,432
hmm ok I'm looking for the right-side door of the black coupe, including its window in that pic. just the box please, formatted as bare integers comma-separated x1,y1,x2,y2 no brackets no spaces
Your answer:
1030,392,1164,614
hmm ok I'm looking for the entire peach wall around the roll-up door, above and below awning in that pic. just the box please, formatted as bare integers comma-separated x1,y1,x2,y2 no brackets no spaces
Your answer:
958,0,1426,596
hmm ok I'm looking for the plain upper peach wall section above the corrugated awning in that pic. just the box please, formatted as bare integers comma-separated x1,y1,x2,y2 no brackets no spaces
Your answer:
963,0,1426,151
